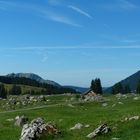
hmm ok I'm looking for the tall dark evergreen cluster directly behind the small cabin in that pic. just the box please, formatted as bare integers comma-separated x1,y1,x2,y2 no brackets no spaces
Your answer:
90,78,103,94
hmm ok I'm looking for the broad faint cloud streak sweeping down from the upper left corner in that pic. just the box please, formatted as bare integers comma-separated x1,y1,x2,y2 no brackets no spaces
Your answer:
0,0,82,27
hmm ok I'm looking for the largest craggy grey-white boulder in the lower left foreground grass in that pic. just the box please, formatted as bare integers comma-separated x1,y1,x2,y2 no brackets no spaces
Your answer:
20,118,60,140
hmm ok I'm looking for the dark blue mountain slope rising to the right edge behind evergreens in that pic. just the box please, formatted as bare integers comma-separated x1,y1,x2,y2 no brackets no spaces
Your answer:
105,71,140,93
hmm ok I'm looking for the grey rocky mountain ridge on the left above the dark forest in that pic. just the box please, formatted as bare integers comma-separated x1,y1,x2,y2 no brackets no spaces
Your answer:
6,73,61,87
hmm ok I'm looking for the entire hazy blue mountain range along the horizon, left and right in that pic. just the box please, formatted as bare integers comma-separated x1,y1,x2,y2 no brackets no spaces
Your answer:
6,71,140,93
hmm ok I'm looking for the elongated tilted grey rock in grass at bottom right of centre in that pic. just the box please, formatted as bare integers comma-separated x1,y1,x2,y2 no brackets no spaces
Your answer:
87,124,111,138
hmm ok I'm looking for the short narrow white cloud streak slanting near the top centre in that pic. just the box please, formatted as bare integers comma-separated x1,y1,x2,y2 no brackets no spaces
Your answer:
68,5,92,19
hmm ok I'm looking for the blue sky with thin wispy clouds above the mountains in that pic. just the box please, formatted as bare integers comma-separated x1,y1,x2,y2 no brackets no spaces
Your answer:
0,0,140,87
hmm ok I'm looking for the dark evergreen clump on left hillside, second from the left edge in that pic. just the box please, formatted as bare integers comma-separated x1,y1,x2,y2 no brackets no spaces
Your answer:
9,85,22,95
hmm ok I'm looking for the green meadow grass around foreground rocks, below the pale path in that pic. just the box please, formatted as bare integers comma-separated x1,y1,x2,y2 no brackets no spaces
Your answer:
0,96,140,140
